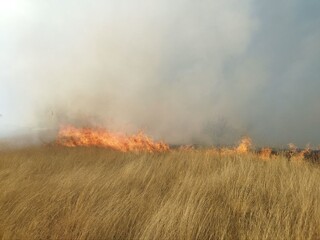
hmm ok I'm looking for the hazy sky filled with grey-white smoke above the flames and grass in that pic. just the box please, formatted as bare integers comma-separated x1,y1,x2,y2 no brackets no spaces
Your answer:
0,0,320,147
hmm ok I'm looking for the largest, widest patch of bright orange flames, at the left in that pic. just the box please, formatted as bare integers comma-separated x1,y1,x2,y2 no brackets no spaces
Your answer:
57,125,169,152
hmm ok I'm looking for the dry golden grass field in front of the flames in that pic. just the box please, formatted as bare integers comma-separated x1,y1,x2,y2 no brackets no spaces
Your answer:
0,146,320,239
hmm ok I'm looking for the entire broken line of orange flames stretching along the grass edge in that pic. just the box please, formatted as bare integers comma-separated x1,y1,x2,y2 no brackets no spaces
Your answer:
56,125,320,162
